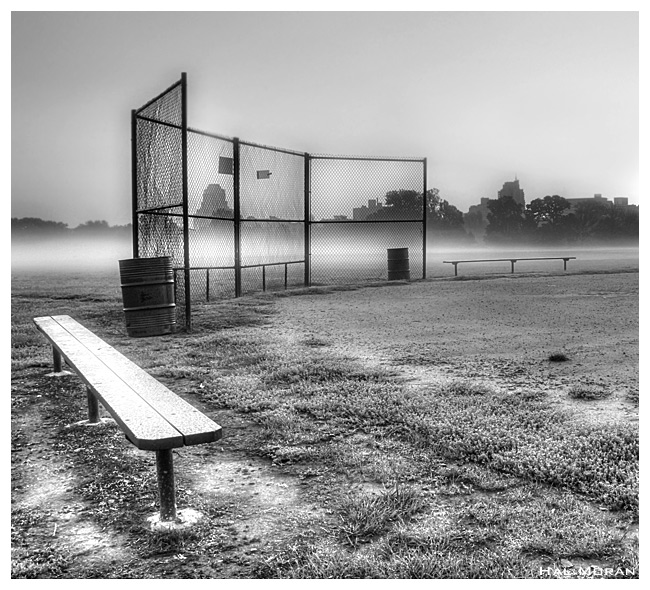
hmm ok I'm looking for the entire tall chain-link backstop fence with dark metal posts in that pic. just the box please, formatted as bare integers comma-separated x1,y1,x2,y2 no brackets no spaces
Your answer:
132,74,427,329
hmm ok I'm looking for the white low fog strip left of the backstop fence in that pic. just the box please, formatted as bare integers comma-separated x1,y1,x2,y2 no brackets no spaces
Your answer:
11,236,133,273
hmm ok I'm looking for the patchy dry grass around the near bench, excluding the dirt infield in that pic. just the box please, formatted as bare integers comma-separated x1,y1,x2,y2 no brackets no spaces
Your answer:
12,272,639,578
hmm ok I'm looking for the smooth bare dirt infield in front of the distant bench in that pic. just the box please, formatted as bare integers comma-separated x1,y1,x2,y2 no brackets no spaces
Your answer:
276,273,639,423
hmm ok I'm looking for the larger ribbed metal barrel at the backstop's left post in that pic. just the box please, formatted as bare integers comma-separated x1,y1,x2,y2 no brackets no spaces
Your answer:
119,256,176,338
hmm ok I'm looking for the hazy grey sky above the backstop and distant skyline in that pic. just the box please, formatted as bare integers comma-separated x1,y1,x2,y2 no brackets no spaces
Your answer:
11,11,639,227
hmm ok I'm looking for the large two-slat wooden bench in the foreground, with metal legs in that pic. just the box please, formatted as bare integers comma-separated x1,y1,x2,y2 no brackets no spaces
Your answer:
34,315,221,521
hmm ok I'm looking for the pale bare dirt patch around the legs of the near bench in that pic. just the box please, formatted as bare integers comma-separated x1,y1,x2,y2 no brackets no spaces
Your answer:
12,380,326,578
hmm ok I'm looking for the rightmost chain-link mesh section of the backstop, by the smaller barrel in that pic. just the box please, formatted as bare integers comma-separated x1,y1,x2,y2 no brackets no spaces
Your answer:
311,156,424,283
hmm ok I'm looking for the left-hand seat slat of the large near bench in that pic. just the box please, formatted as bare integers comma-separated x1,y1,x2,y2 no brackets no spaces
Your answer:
34,317,183,450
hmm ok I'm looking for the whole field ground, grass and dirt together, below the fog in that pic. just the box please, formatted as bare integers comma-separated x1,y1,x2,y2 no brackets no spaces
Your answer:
11,272,639,578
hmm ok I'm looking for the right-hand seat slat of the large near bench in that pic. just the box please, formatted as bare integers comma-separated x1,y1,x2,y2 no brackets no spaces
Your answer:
53,316,221,445
